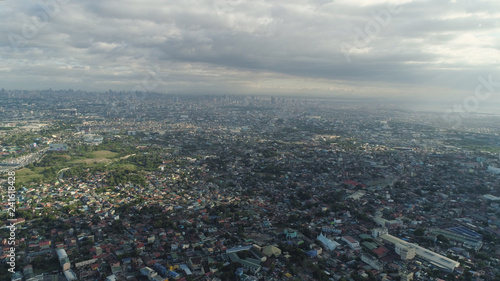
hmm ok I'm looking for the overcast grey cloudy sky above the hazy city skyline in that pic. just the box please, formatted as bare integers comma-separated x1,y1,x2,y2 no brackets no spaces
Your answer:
0,0,500,101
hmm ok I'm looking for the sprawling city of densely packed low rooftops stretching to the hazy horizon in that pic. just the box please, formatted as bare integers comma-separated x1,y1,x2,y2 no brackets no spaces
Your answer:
0,90,500,281
